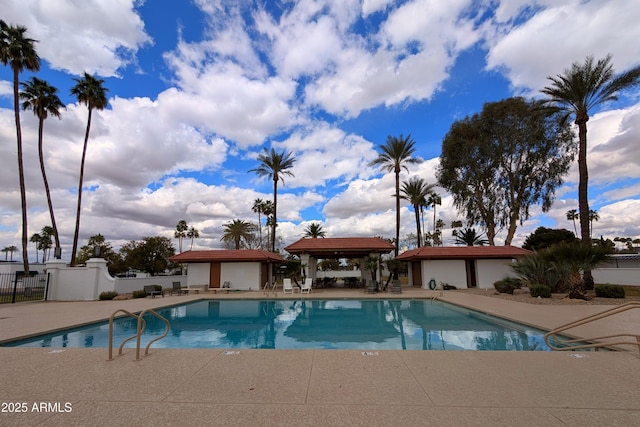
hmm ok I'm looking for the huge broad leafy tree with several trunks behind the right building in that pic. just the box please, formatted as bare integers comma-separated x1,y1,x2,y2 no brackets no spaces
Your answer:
437,98,575,245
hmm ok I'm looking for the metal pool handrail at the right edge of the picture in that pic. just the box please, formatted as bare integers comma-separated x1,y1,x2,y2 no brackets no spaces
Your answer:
544,301,640,353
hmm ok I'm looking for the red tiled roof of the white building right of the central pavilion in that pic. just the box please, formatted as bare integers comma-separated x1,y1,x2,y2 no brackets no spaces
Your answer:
398,246,532,261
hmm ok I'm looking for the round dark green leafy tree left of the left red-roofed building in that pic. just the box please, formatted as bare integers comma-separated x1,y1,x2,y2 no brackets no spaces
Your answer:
120,236,176,276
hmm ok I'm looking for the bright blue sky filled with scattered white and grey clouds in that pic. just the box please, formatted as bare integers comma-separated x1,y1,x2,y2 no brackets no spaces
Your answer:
0,0,640,257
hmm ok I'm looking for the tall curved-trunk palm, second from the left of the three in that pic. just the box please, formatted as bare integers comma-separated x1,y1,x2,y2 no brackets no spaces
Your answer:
20,77,64,256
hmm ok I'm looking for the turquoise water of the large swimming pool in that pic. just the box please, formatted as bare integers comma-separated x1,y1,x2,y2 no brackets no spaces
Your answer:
5,299,550,351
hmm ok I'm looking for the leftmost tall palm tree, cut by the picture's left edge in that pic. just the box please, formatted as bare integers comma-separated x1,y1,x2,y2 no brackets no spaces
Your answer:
0,19,40,274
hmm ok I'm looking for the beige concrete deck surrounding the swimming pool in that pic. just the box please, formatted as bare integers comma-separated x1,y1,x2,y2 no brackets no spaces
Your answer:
0,288,640,426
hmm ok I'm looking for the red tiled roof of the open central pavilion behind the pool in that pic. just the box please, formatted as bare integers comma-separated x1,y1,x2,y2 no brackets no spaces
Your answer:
284,237,395,258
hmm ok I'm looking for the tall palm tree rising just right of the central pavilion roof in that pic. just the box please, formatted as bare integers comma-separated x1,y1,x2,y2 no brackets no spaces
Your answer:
369,134,422,260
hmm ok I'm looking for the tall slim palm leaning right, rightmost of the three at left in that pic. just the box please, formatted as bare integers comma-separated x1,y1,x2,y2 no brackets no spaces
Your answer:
71,72,108,265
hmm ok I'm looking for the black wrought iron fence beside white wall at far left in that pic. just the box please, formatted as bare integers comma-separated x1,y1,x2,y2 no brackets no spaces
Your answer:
0,271,49,304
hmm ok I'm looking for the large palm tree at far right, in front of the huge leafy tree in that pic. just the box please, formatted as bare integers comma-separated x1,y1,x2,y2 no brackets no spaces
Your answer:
542,55,640,244
